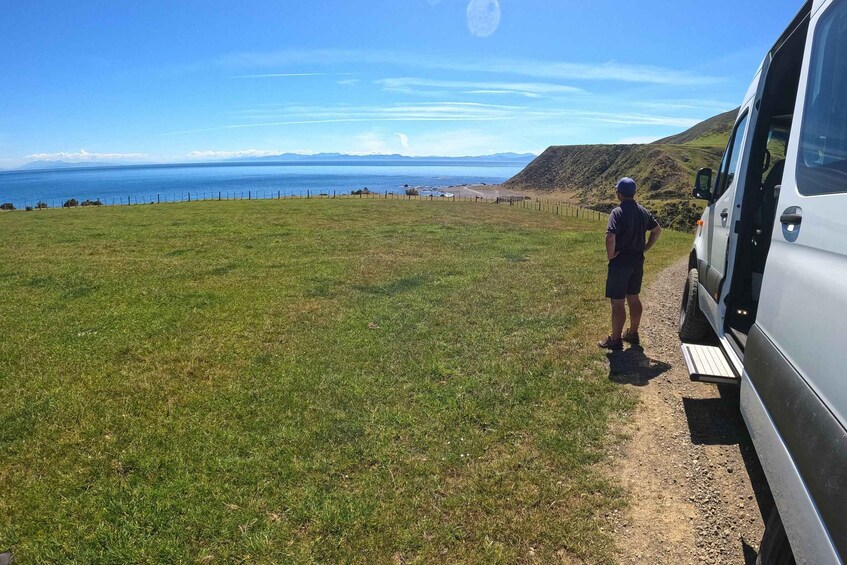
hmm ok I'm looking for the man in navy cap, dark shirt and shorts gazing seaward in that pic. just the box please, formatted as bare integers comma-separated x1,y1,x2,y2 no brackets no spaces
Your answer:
597,177,662,351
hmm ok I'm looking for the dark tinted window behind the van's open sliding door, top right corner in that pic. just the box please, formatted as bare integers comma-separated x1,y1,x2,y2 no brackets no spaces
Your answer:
797,2,847,195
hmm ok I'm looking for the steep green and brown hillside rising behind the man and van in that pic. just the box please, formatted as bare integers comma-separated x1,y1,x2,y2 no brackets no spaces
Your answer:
504,109,737,229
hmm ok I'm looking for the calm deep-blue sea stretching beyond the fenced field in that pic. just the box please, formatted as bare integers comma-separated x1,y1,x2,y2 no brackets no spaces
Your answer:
0,162,523,208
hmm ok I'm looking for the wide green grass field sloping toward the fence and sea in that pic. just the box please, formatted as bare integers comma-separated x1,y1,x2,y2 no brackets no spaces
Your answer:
0,200,690,563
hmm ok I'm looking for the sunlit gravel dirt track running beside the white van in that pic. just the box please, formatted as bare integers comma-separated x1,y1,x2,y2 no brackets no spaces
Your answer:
609,261,773,563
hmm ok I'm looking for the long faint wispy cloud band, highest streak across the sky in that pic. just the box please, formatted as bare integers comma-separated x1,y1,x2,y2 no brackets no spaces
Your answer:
217,49,724,86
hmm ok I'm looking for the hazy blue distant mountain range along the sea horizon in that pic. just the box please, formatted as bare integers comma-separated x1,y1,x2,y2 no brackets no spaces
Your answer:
15,153,536,171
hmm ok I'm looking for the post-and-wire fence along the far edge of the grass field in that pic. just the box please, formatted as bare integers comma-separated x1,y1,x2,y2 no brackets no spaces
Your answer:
0,189,608,221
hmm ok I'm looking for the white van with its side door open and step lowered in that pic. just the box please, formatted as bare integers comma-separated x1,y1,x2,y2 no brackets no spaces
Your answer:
679,0,847,563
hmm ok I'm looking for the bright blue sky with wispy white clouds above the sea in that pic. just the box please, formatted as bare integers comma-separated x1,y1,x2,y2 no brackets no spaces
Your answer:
0,0,801,168
